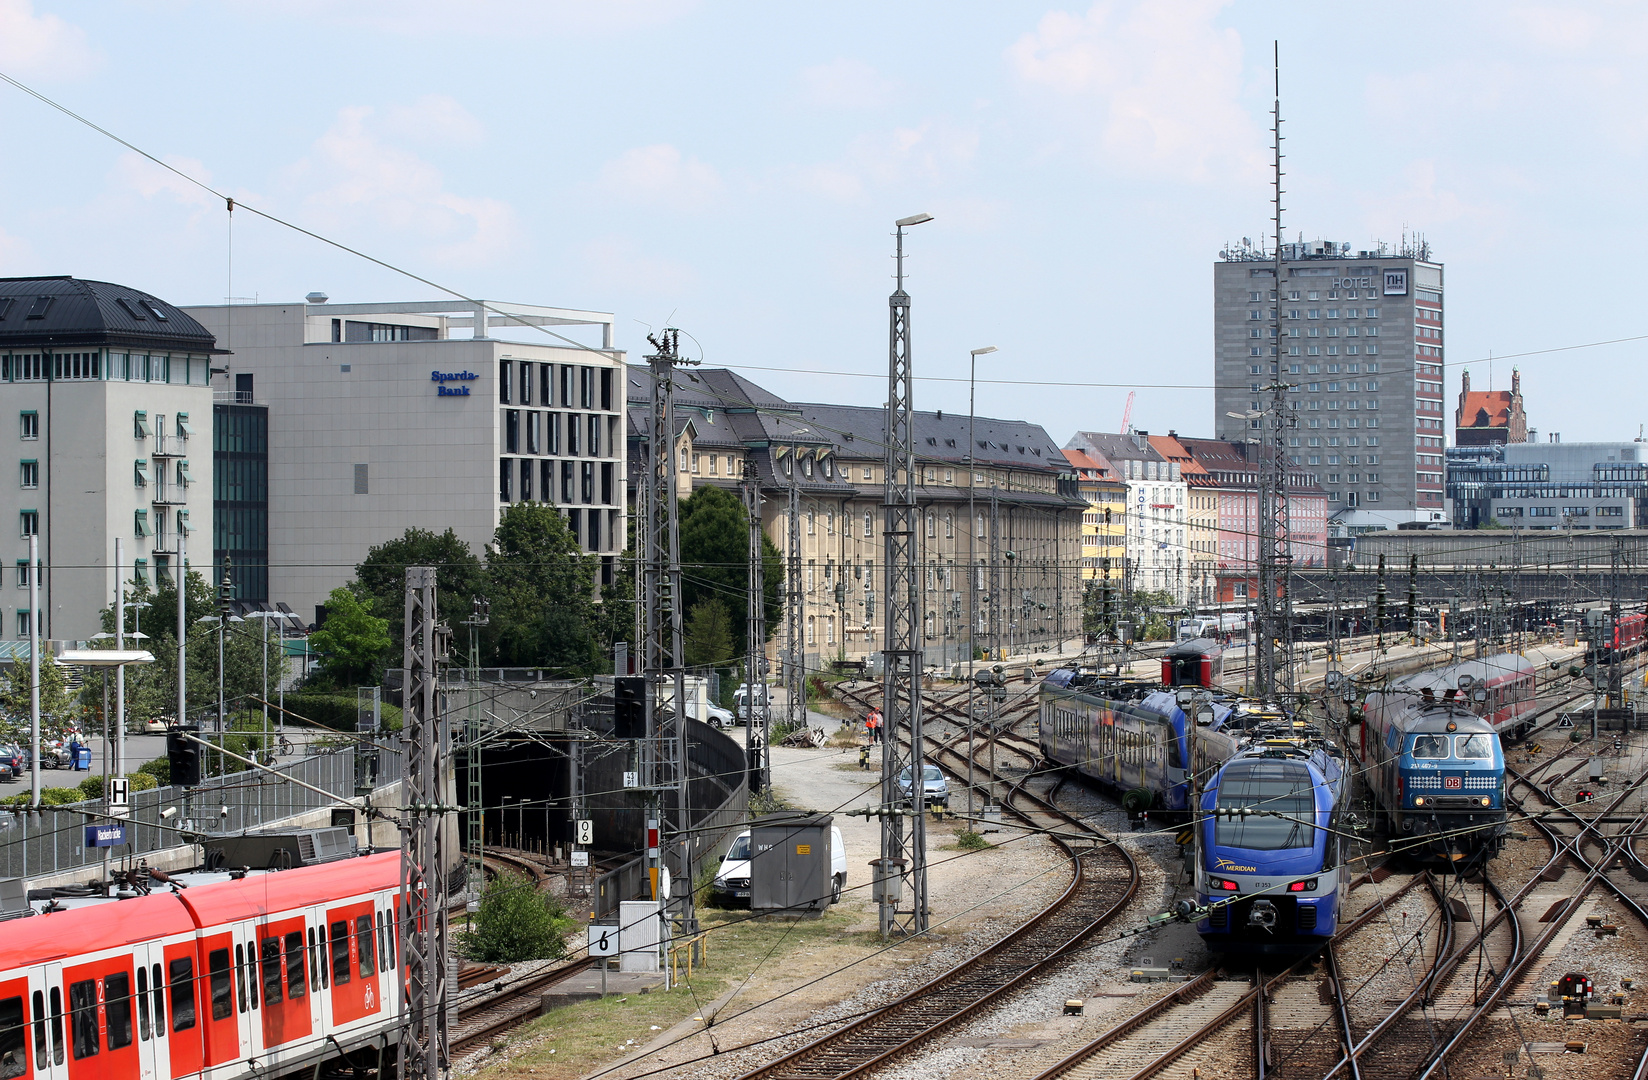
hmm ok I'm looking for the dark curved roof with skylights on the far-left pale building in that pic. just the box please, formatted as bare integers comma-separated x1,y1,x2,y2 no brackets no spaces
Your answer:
0,277,224,353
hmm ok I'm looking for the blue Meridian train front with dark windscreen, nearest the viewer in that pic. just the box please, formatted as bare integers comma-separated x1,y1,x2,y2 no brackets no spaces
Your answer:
1193,721,1348,955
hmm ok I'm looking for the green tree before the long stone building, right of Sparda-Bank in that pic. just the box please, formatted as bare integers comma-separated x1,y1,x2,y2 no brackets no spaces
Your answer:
681,486,784,636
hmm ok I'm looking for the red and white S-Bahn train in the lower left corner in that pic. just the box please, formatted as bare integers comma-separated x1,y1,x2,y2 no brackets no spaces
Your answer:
0,852,402,1080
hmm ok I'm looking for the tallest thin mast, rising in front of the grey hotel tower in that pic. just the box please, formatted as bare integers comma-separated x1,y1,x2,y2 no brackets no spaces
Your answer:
1254,46,1294,697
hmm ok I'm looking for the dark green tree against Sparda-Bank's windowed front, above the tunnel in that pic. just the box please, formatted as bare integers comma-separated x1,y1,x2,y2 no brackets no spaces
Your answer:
485,503,600,674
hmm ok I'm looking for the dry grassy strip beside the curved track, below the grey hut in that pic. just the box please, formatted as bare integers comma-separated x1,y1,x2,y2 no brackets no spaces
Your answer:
481,909,880,1080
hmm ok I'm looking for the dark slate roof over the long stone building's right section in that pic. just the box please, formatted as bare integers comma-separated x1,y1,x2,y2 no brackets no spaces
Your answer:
798,404,1070,473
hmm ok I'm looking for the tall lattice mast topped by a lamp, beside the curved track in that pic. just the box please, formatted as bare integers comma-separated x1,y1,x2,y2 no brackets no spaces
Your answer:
878,214,933,937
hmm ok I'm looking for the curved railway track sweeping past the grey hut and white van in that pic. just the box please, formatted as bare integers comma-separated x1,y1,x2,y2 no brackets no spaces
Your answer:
728,702,1139,1080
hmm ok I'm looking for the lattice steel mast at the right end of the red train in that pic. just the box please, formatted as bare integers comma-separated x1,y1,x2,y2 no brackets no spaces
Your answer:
396,566,453,1080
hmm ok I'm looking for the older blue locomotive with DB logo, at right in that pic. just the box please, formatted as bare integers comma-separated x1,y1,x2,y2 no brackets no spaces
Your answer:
1358,664,1506,862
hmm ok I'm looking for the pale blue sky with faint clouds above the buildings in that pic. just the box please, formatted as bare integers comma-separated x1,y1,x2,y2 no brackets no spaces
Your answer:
0,0,1648,444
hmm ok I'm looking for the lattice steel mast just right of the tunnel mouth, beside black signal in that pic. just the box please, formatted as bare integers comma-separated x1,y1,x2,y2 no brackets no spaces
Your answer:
641,326,697,933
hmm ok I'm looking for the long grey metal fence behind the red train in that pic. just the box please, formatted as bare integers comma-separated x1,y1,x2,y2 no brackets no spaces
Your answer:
0,750,402,877
